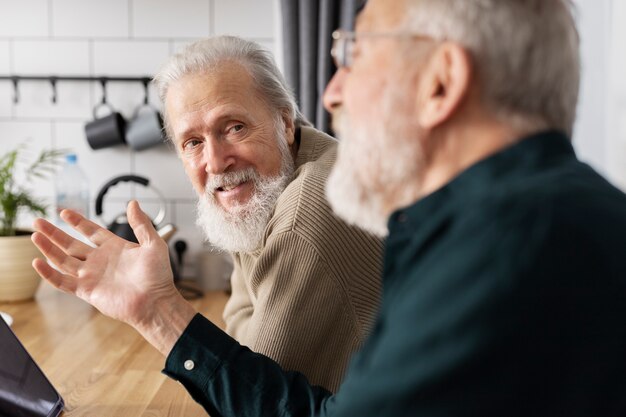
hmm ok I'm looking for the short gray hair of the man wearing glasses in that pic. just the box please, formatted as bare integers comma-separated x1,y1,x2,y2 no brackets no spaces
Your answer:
406,0,580,135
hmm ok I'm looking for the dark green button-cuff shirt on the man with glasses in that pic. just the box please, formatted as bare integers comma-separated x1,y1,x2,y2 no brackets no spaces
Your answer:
164,128,626,417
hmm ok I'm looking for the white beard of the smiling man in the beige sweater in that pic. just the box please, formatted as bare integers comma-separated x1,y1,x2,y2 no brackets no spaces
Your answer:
196,132,295,252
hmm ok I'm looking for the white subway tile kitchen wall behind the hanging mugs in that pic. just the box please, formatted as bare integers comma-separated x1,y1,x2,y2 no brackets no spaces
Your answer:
0,0,276,277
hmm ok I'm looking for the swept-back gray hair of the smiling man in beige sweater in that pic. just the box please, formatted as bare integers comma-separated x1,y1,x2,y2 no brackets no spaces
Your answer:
153,36,311,140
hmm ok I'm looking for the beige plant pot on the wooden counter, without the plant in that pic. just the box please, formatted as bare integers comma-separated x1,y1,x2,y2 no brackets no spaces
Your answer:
0,231,43,301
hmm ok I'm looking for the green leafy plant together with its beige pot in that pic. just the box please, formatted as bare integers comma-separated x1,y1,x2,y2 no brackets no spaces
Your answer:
0,146,65,301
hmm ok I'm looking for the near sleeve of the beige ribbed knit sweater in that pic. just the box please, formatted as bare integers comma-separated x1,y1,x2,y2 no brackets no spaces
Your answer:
231,232,361,391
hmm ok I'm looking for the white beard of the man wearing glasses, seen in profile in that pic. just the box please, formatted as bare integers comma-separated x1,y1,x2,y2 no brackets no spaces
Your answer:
326,93,424,237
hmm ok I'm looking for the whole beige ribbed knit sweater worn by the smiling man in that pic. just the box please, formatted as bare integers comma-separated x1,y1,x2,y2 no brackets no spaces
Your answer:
224,128,383,391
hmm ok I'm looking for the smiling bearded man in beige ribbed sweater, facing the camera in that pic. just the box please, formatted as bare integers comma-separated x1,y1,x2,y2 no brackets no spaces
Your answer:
154,36,382,391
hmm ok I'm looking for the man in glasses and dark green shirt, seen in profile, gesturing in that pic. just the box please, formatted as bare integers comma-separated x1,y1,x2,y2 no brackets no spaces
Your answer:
35,0,626,417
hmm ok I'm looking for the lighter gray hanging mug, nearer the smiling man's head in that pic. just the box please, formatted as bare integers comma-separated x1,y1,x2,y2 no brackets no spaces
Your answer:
126,104,165,151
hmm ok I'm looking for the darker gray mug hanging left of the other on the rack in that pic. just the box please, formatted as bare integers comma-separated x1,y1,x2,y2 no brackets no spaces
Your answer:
85,103,126,150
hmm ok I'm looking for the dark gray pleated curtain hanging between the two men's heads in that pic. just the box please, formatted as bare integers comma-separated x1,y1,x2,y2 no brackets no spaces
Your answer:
280,0,364,133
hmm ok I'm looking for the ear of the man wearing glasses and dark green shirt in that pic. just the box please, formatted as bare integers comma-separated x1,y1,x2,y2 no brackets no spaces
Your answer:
417,42,472,129
